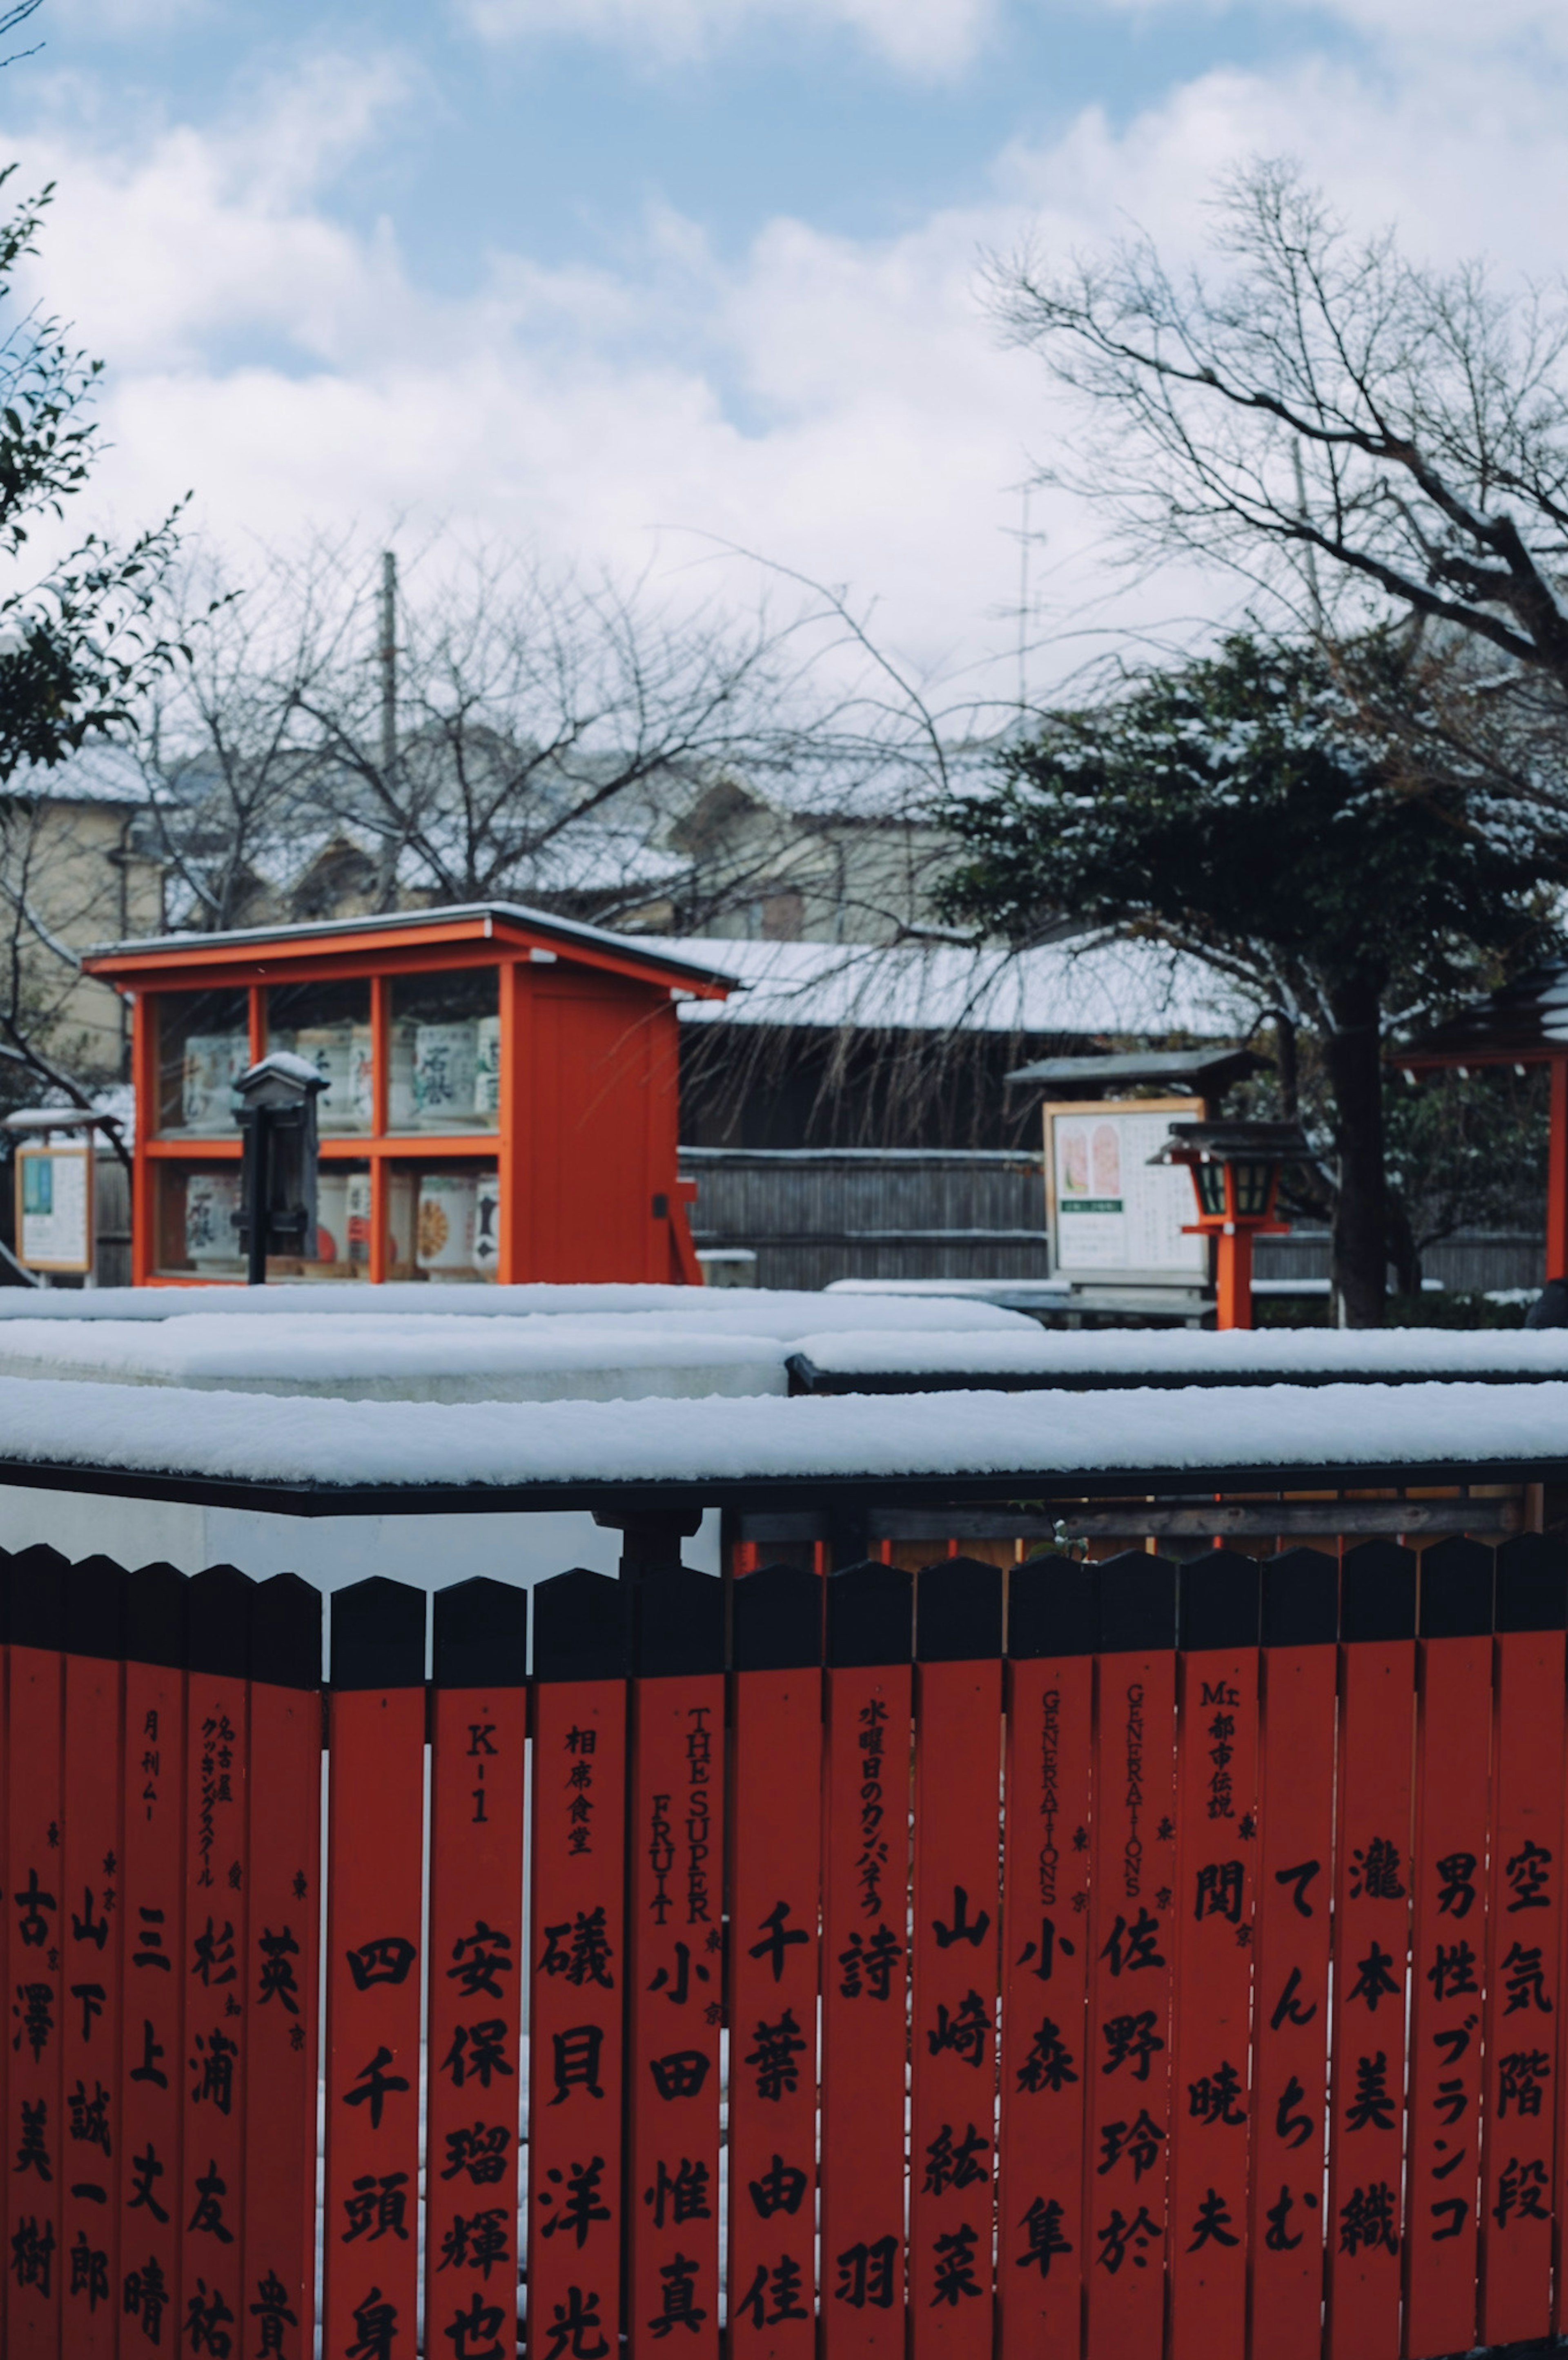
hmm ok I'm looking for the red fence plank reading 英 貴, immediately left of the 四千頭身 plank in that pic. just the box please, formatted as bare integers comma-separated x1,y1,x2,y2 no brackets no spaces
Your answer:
236,1574,321,2360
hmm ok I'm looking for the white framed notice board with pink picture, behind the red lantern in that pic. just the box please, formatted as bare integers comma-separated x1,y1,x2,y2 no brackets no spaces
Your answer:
1045,1097,1209,1286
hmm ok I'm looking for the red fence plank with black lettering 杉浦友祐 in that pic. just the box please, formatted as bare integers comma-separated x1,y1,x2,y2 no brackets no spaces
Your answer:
174,1565,255,2348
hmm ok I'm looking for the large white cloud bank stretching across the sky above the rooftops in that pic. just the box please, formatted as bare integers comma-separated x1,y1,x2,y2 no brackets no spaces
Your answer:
3,13,1568,703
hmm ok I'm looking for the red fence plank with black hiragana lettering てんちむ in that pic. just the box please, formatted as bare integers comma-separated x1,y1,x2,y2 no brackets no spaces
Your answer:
1250,1548,1339,2360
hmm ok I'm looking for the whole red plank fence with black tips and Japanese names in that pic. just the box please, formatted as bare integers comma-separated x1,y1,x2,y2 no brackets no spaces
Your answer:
0,1536,1568,2360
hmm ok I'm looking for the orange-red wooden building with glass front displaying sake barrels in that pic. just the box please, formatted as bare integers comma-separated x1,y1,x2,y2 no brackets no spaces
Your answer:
85,901,733,1286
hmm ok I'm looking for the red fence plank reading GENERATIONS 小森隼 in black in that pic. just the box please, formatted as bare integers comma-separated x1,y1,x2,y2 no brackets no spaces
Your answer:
998,1557,1099,2360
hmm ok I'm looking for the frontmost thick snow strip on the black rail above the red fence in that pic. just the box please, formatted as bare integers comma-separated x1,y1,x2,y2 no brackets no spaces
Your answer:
0,1378,1568,1506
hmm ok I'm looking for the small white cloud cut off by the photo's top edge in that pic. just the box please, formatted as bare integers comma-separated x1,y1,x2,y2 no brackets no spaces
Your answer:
462,0,995,76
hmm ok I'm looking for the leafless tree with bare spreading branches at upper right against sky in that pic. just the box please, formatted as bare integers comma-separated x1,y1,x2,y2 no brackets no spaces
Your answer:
990,161,1568,708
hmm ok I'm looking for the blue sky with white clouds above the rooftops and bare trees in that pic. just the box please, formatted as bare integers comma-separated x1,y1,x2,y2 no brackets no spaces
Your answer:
0,0,1568,685
